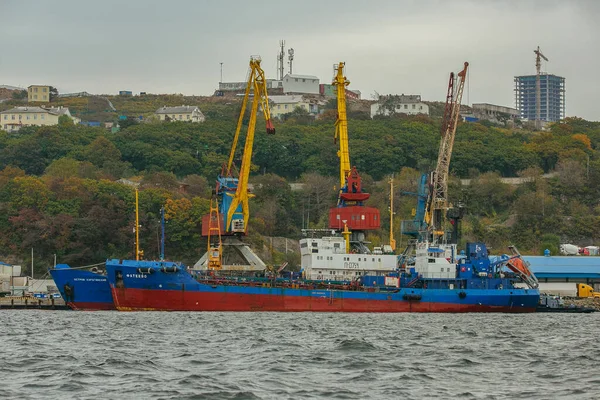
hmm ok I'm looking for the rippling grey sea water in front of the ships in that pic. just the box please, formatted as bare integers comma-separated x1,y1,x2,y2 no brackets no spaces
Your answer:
0,310,600,399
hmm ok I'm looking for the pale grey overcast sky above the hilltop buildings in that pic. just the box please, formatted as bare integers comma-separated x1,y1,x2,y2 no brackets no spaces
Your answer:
0,0,600,121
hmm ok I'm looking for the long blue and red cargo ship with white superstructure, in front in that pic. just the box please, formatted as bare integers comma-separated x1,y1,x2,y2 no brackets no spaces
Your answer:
106,237,540,313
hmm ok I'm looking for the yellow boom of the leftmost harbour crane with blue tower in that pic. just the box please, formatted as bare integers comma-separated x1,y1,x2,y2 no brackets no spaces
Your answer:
225,57,275,232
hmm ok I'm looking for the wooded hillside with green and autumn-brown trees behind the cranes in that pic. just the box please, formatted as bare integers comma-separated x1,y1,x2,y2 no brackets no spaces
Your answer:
0,99,600,276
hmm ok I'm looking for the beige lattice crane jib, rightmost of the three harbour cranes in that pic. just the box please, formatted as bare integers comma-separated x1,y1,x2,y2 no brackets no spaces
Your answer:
425,62,469,242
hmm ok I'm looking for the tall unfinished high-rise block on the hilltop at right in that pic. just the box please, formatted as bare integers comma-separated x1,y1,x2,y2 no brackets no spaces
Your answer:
515,73,565,122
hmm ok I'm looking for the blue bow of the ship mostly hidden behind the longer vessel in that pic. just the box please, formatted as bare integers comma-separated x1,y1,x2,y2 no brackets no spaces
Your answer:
50,264,115,310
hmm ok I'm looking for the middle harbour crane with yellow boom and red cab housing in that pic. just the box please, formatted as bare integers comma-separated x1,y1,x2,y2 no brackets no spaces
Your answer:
329,62,380,252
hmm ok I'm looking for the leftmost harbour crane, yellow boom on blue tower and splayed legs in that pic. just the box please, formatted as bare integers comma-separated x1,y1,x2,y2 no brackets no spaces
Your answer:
196,57,275,270
